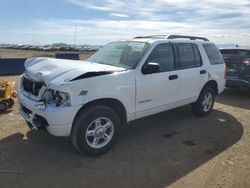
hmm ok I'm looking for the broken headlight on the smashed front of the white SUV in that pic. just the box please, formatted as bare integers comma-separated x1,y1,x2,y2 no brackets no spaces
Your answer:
43,89,70,106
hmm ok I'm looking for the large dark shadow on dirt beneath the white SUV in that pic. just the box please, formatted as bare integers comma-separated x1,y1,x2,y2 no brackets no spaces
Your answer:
0,106,243,188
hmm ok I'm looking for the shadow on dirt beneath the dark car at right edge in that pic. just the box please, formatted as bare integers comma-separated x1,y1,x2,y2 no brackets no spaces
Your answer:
216,88,250,110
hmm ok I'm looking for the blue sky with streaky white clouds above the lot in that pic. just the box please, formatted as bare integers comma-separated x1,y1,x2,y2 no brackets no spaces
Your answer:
0,0,250,46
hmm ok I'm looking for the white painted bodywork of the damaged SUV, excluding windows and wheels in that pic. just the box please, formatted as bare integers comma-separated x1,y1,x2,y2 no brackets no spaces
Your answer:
18,36,225,136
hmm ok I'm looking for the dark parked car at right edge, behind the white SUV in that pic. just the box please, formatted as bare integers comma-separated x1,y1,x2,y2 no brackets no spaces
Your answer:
220,48,250,88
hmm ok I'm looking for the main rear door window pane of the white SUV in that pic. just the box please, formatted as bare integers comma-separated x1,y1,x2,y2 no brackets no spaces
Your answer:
176,43,196,69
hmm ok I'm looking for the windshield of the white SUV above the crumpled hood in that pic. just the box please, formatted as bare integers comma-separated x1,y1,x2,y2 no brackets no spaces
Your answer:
88,42,148,69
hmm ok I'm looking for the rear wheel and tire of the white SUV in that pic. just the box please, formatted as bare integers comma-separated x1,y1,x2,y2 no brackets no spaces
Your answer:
192,87,215,117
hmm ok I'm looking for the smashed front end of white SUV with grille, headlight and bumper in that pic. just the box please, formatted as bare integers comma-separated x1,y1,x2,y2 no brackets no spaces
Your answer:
18,74,78,136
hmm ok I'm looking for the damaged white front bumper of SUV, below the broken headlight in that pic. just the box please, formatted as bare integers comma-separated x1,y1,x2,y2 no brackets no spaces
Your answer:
18,92,81,136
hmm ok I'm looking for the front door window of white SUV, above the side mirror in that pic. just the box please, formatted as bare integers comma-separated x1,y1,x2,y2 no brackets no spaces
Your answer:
147,44,175,72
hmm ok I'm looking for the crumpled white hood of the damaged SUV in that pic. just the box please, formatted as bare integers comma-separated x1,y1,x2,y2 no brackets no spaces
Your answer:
25,58,125,85
